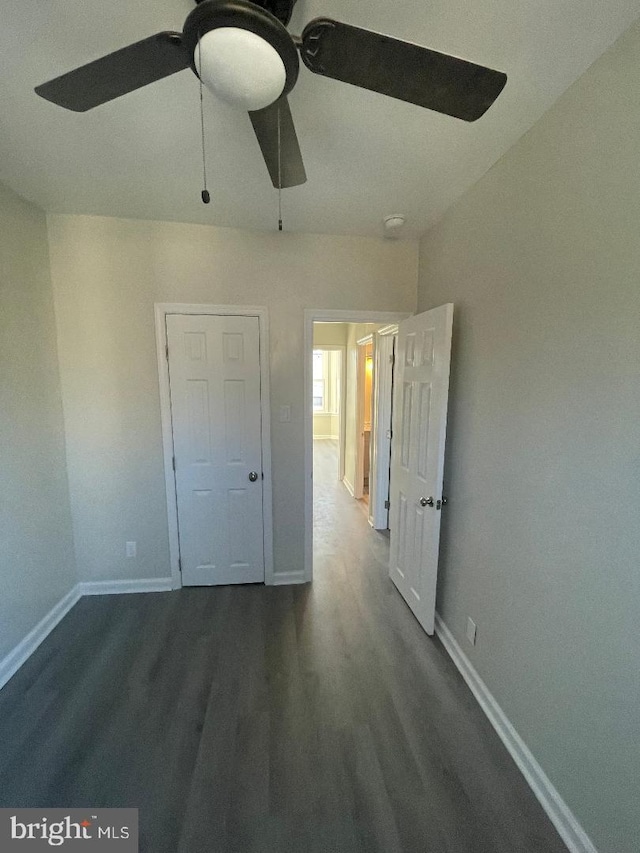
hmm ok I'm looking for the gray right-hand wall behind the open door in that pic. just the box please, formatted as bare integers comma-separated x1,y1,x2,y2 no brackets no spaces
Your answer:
418,20,640,853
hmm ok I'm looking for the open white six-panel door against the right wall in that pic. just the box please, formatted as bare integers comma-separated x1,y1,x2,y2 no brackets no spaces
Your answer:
389,304,453,634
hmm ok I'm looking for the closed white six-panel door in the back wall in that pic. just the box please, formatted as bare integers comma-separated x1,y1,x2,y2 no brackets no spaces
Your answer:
166,314,265,586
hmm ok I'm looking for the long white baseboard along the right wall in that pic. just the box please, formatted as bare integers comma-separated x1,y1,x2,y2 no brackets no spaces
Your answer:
436,613,598,853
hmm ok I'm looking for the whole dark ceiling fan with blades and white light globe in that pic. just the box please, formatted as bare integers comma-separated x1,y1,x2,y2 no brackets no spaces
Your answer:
35,0,507,188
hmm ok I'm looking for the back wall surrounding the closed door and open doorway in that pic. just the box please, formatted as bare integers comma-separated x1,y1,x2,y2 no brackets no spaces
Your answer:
48,216,418,580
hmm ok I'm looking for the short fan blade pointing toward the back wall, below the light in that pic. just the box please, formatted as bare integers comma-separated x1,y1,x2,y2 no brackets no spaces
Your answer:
249,97,307,189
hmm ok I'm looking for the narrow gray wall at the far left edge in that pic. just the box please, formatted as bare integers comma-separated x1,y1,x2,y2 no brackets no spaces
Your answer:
0,180,76,660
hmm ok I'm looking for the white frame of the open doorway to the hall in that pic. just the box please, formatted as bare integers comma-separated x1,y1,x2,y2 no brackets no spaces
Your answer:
303,308,412,581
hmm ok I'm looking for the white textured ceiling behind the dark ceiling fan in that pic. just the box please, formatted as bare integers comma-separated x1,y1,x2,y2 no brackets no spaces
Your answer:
0,0,640,236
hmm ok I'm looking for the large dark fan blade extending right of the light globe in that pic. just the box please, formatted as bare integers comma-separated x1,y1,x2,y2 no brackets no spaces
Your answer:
300,18,507,121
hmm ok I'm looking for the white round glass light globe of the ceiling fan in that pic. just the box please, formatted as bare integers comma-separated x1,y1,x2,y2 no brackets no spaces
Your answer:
193,27,287,111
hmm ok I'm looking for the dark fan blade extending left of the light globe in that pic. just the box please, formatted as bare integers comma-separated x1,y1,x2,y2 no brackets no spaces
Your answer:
36,32,189,112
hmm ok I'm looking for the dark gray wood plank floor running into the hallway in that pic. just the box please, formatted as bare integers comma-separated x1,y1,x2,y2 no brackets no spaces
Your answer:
0,443,566,853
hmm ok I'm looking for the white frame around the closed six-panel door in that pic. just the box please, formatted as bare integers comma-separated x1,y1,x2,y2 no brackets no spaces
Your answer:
154,302,274,589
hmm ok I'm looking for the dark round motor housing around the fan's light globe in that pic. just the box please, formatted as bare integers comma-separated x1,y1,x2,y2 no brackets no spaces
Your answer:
182,0,300,97
